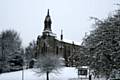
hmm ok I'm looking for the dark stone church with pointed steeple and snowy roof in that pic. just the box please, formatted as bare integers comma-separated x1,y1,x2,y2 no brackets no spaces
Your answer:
35,9,81,66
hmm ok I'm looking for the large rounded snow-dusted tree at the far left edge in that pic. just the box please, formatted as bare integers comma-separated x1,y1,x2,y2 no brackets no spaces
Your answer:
0,30,22,73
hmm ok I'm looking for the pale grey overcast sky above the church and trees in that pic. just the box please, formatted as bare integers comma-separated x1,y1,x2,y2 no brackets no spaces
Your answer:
0,0,119,46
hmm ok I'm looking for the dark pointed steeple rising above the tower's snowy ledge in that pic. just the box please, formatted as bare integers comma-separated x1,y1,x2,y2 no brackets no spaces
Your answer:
44,9,52,32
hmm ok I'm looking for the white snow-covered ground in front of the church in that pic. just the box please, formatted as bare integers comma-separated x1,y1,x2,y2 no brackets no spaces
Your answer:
0,67,104,80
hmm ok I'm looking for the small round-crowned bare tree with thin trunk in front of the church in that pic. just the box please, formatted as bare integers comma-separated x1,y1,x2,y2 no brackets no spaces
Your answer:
34,55,63,80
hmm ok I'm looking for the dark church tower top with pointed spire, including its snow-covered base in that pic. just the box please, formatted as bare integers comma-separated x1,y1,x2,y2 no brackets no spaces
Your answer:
43,9,52,36
